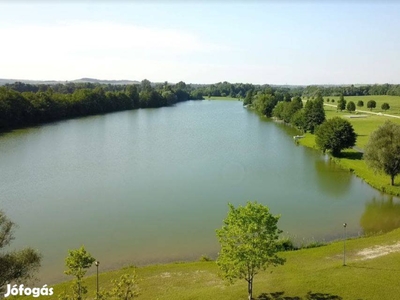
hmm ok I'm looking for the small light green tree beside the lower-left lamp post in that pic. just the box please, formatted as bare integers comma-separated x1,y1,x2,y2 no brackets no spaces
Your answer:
64,246,95,300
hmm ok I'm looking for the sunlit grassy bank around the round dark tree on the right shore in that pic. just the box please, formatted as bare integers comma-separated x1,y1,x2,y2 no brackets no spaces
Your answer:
299,103,400,196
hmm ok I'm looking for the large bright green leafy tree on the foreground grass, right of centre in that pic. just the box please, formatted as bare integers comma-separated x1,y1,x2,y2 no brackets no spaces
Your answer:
217,202,285,300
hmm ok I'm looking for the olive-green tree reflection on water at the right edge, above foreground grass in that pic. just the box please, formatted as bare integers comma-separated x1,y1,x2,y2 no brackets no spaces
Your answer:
360,196,400,234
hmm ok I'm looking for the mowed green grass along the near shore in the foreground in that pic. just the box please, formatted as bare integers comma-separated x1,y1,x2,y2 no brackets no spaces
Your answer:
16,229,400,300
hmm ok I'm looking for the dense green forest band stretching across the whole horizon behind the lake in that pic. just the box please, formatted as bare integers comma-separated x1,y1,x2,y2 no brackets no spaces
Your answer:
0,79,400,130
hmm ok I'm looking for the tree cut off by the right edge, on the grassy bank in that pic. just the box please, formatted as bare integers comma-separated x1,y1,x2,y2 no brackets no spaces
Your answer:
364,121,400,185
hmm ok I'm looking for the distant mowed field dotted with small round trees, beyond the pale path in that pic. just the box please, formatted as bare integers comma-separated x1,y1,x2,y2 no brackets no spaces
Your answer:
324,95,400,115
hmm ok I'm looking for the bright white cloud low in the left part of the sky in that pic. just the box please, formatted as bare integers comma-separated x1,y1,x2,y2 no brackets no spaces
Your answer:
0,22,227,80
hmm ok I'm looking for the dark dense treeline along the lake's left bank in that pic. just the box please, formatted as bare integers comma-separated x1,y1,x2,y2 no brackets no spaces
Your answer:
0,80,202,129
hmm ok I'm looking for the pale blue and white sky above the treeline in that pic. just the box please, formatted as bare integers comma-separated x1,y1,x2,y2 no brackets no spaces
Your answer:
0,0,400,85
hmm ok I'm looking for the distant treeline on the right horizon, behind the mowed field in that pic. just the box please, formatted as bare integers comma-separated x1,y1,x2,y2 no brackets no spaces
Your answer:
302,84,400,97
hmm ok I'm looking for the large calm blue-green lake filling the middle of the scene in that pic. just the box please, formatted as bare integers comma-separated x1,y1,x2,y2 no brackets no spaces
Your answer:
0,100,399,284
